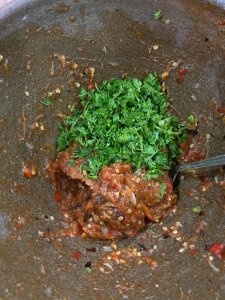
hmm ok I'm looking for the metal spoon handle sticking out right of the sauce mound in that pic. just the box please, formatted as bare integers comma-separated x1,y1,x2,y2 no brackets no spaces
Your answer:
173,154,225,182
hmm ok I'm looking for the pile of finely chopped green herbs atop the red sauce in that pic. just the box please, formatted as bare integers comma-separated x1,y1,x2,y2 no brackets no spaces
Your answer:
57,73,186,179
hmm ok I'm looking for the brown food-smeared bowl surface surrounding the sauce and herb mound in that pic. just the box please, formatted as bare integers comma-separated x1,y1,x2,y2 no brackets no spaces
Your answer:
0,0,225,299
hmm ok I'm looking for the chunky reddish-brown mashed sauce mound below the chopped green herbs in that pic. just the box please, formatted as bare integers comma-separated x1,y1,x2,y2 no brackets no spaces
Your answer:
49,151,177,239
